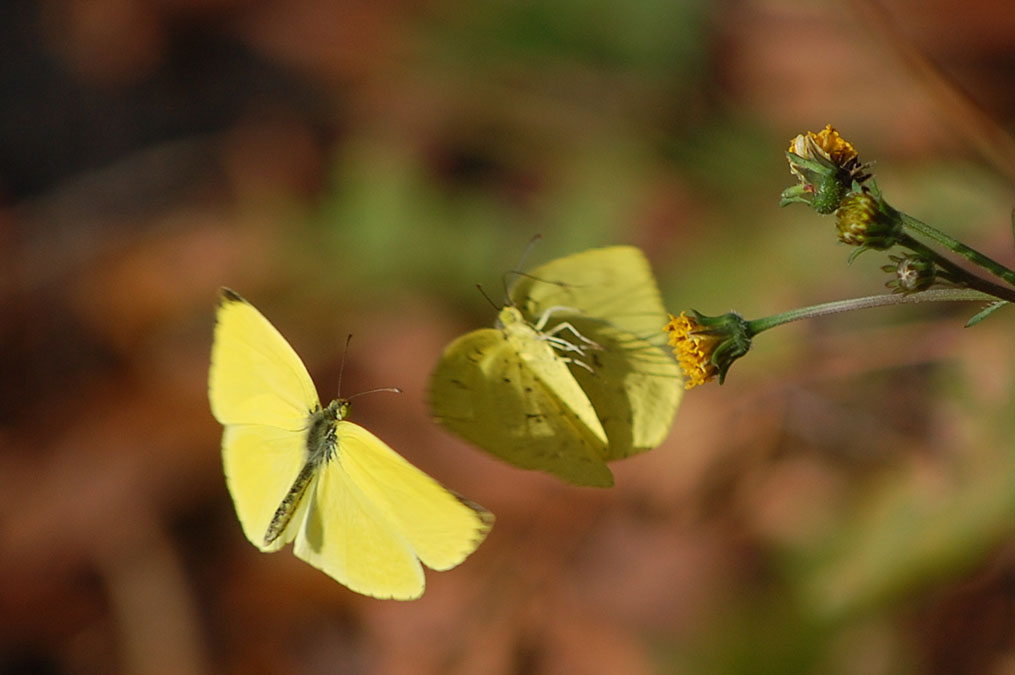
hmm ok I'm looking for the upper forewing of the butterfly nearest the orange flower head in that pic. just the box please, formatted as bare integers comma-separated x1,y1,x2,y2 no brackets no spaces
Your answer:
511,246,666,344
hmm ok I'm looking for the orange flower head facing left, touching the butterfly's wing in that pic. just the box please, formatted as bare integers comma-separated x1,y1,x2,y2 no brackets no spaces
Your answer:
666,310,751,389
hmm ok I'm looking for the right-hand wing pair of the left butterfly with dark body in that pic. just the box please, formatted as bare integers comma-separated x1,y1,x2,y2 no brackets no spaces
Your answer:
293,421,493,600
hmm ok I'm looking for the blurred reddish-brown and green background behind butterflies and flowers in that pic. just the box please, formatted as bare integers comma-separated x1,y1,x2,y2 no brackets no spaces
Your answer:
0,0,1015,675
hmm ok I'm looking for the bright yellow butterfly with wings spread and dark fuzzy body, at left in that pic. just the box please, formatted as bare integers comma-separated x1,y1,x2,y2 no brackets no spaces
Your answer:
208,288,493,600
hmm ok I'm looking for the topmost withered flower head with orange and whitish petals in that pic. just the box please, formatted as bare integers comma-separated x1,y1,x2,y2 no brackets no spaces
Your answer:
781,124,871,214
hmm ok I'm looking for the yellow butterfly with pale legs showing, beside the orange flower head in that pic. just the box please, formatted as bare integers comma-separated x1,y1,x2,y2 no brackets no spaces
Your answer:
429,247,683,487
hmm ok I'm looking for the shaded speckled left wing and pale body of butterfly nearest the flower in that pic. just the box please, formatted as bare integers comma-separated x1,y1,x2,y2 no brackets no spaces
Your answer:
429,308,613,487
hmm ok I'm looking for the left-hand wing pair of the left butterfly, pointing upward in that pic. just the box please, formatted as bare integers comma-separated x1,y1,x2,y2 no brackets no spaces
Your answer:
208,288,319,551
